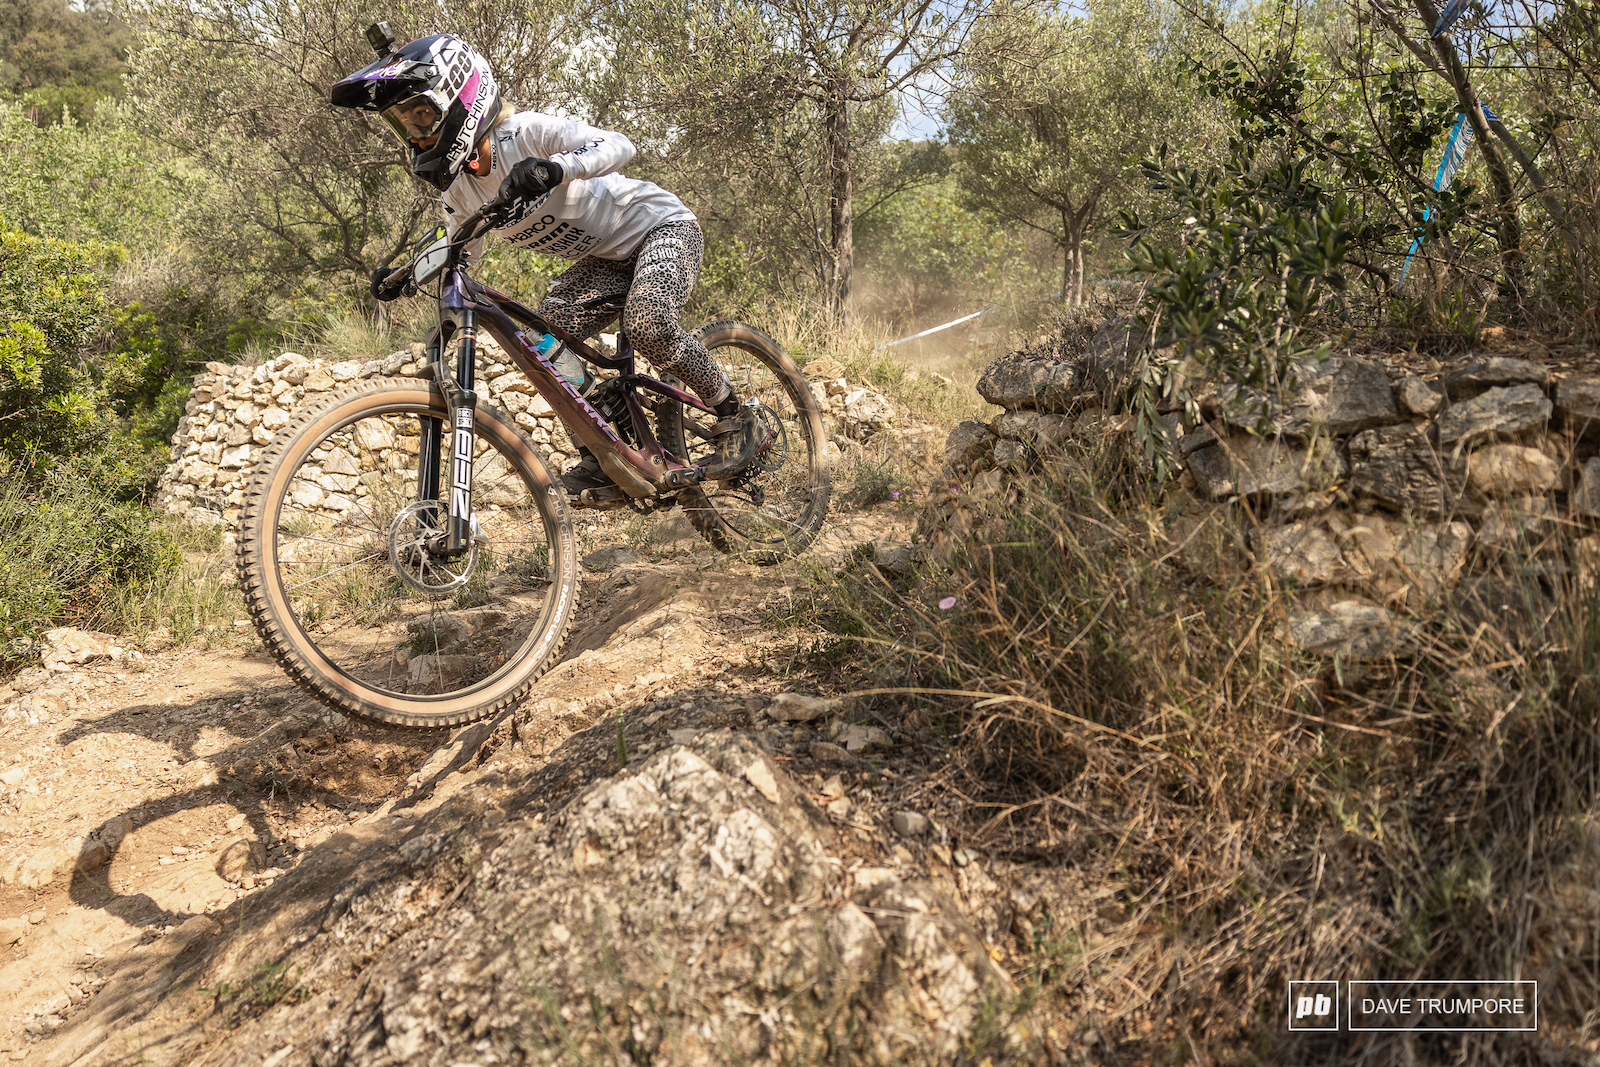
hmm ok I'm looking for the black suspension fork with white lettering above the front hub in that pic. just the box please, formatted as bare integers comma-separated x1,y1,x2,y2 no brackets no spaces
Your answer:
418,275,478,557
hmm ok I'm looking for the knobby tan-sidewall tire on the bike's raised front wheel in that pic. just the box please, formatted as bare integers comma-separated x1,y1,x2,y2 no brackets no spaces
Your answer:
237,382,578,726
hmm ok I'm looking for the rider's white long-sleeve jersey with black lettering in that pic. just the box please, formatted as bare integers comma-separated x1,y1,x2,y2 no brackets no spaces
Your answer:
443,110,694,259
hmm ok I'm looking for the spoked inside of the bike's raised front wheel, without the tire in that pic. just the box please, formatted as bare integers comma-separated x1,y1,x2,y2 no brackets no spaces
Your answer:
277,399,569,696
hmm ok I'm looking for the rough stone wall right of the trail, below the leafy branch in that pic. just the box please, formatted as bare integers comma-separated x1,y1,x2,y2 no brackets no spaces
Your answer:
934,349,1600,653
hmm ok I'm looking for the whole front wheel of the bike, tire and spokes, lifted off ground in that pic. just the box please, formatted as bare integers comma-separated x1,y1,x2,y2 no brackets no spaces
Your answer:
238,382,578,726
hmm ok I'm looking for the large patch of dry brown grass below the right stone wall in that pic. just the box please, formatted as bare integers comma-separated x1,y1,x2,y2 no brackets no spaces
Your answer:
830,438,1600,1064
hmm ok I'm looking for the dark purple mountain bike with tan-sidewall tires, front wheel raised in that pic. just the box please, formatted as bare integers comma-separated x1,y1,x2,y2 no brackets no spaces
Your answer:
237,194,832,726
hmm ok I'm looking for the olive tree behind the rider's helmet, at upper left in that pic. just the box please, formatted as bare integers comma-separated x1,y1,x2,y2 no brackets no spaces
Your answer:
130,0,601,300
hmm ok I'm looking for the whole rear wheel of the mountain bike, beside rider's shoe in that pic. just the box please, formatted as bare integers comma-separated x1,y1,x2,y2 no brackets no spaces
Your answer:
656,322,834,563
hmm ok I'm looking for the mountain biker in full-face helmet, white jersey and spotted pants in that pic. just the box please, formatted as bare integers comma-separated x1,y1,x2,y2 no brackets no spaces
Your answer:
330,26,757,493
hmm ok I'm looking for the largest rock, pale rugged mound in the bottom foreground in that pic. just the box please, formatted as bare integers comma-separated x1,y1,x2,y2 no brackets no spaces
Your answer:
112,733,1029,1067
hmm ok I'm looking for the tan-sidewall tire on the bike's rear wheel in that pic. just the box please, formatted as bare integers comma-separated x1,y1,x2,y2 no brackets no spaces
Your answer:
678,320,834,565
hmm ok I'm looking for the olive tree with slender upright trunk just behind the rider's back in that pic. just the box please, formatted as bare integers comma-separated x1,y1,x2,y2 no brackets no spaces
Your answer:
618,0,987,325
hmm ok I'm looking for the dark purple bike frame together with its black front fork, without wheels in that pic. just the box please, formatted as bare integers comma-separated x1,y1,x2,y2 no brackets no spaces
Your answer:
418,256,715,555
